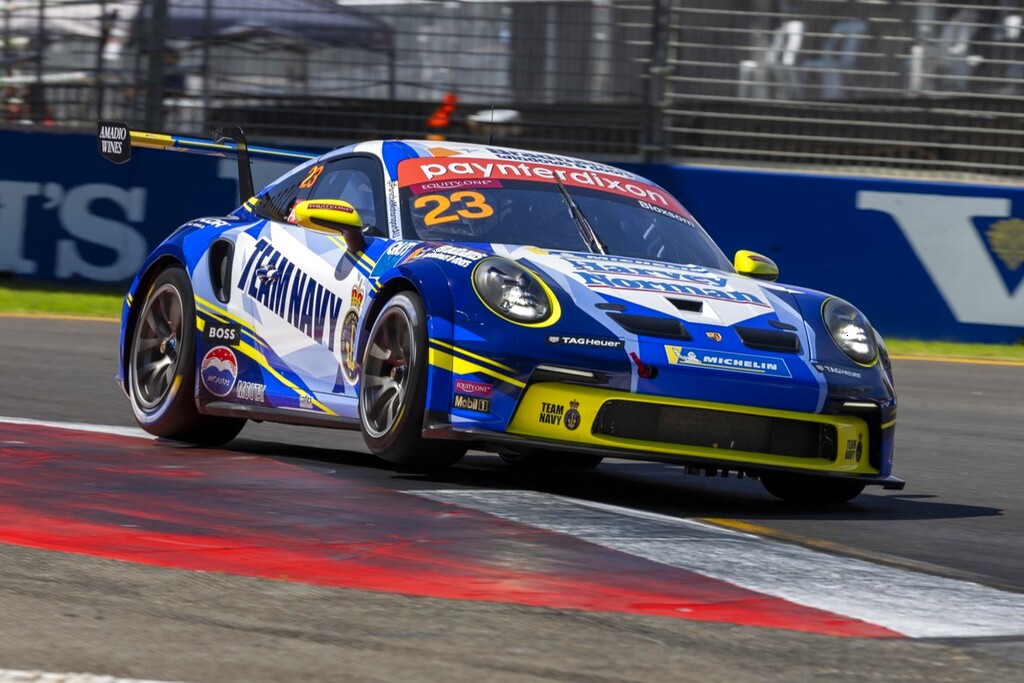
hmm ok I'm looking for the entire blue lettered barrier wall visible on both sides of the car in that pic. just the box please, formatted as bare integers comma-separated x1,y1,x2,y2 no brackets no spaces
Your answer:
0,127,1024,342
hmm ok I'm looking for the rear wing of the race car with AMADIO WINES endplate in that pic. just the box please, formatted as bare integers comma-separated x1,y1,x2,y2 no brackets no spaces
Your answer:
96,121,316,204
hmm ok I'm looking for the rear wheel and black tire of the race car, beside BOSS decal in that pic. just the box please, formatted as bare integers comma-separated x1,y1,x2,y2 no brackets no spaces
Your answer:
126,266,246,445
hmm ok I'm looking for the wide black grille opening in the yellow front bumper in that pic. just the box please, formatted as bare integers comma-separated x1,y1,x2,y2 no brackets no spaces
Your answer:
593,400,838,461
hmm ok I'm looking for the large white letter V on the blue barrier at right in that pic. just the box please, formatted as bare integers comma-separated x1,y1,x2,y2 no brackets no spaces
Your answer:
857,190,1024,327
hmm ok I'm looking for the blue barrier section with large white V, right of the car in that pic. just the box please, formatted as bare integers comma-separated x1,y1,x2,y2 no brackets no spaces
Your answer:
618,166,1024,342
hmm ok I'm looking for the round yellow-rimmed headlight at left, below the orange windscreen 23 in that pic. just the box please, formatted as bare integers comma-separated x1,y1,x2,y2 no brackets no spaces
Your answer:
473,257,552,325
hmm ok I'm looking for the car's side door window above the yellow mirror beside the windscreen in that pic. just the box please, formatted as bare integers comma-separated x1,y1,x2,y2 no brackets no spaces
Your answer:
309,157,387,236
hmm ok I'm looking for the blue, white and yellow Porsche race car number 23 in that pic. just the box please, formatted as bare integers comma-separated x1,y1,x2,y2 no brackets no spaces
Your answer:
108,126,903,503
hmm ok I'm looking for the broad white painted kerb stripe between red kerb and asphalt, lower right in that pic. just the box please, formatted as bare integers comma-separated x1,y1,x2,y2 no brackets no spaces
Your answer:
408,490,1024,638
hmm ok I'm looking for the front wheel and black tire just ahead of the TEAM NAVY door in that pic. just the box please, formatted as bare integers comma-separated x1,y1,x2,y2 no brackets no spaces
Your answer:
359,291,466,472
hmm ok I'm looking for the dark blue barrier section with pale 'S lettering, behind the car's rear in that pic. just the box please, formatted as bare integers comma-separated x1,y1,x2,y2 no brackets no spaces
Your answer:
0,127,238,286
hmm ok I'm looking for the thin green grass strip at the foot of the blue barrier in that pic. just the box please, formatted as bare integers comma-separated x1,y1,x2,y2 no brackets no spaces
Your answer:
0,281,1024,361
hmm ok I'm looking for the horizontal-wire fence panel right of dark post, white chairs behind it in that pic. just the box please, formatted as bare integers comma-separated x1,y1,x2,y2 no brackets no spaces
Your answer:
663,0,1024,178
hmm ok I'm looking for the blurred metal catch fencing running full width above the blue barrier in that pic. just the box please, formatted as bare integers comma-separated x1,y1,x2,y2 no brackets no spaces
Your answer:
0,0,1024,181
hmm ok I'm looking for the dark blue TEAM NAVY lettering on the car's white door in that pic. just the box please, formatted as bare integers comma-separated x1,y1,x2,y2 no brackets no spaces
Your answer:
239,238,344,351
